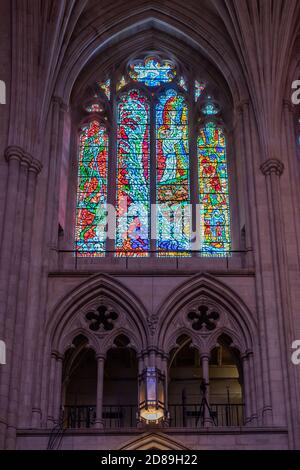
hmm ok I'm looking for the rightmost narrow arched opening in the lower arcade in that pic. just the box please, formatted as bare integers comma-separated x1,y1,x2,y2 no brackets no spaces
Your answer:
209,334,243,426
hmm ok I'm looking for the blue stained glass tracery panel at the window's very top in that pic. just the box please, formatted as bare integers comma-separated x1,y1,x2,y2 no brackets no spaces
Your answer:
129,57,176,86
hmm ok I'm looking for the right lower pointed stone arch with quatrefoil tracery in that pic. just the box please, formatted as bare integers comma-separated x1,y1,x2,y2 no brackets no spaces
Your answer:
155,273,257,352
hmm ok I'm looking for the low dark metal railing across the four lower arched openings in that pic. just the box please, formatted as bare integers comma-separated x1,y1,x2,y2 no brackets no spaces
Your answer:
64,403,245,429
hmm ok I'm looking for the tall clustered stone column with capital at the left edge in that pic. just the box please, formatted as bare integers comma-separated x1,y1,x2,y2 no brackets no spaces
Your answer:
0,146,42,449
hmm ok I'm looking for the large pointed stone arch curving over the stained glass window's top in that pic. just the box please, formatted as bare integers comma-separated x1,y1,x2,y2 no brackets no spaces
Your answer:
54,4,247,106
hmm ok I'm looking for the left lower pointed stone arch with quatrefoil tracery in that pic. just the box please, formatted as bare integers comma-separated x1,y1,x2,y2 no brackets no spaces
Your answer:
46,274,148,354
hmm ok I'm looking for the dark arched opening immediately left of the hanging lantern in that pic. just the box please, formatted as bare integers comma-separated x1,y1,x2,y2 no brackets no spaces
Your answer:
102,335,138,428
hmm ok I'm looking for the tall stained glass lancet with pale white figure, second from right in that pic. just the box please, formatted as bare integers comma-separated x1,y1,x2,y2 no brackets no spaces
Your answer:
156,89,190,256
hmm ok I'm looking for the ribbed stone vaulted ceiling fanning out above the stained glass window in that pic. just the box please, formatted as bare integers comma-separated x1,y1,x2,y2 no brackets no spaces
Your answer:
10,0,300,160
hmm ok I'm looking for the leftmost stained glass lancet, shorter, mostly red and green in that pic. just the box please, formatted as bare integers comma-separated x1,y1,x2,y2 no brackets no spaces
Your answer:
75,121,108,256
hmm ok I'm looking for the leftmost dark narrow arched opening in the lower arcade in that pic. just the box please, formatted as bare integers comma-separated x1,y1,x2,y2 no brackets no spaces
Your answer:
62,335,97,428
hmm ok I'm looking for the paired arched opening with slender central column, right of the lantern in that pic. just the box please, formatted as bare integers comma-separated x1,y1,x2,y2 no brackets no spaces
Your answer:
168,334,244,428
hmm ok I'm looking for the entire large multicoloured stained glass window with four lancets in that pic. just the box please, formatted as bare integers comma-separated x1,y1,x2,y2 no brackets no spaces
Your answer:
75,54,231,258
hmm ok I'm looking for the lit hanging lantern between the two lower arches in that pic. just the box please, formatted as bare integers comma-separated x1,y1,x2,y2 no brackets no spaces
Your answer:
139,367,166,424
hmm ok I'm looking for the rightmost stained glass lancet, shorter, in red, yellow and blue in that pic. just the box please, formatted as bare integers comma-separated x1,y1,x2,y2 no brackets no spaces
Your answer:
198,122,231,256
